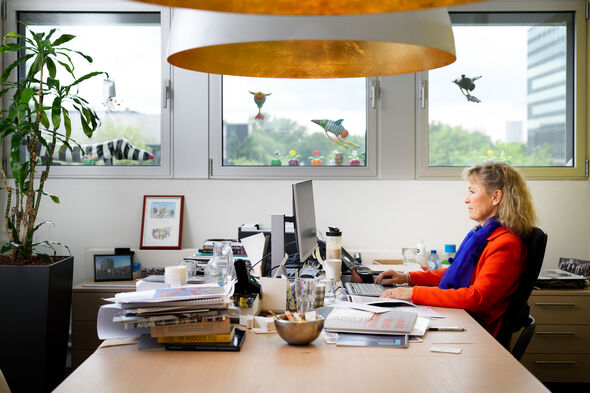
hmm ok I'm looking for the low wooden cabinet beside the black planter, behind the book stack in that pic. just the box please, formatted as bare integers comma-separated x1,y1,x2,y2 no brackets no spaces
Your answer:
72,281,135,370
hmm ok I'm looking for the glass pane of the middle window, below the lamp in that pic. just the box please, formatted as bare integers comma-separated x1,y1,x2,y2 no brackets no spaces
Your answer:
222,76,367,167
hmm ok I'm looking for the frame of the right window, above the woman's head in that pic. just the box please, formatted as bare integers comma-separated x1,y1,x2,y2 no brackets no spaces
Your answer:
416,0,588,179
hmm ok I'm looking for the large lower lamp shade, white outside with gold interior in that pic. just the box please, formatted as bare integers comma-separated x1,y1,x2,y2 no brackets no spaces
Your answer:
168,8,456,78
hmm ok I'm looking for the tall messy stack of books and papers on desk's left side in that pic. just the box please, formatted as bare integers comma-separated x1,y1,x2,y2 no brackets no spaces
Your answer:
108,284,243,350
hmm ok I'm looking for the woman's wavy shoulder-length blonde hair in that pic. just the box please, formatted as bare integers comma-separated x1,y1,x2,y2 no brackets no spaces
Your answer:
463,161,537,237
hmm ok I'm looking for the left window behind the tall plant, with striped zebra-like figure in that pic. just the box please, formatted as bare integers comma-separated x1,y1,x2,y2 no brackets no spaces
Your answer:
8,3,170,177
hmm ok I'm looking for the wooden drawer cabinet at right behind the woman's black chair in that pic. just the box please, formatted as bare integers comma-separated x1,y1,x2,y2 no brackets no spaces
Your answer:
522,289,590,383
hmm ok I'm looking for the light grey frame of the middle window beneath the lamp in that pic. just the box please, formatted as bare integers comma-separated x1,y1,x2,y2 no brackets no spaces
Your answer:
209,74,379,179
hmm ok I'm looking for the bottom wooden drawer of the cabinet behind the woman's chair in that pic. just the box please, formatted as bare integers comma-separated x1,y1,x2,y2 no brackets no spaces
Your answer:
521,353,590,382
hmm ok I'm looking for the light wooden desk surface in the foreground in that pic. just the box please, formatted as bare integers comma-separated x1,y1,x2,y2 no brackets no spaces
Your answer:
54,308,548,393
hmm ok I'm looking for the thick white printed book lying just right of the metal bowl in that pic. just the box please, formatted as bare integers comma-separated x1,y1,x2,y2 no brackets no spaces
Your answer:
324,308,417,334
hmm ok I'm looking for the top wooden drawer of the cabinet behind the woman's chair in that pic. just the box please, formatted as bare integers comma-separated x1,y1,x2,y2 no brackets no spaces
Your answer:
529,296,590,324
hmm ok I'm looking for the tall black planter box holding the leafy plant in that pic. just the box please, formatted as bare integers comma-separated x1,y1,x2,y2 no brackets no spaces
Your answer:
0,256,74,393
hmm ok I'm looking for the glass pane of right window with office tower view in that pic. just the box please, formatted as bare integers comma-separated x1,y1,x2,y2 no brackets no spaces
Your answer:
428,13,574,167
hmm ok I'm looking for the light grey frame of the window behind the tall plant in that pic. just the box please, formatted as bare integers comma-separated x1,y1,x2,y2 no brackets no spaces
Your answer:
2,0,172,178
